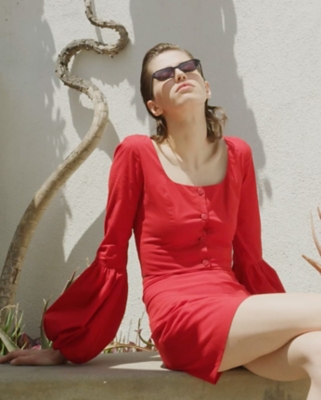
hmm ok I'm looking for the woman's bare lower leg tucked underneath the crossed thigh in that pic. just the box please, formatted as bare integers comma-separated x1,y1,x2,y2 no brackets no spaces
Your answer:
244,332,321,400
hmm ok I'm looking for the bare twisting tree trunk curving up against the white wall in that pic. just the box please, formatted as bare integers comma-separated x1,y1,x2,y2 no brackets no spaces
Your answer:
0,0,128,310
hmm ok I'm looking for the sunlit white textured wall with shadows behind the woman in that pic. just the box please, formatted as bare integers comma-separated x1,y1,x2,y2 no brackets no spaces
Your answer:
0,0,321,338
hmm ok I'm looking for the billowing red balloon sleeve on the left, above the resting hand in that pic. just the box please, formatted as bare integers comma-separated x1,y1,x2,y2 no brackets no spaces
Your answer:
44,137,143,363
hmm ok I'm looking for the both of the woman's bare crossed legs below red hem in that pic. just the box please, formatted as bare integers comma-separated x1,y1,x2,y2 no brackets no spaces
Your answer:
219,294,321,400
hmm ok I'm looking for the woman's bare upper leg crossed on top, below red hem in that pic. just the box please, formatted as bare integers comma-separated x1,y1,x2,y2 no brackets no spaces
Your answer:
219,293,321,370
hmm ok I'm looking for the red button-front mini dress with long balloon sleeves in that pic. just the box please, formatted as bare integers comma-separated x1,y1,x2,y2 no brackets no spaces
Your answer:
44,135,284,383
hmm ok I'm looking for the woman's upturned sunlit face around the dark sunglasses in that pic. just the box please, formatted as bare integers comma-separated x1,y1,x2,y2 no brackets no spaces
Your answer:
147,50,210,117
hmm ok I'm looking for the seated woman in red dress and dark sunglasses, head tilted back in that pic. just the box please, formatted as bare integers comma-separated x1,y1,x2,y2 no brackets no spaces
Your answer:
0,44,321,400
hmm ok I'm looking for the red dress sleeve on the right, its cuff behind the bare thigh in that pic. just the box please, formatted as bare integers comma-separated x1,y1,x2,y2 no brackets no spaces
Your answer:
233,141,285,294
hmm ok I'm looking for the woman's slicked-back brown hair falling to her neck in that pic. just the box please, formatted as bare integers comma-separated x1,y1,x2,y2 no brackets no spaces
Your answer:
140,43,227,143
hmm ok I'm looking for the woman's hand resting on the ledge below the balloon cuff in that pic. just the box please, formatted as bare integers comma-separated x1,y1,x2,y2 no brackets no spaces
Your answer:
0,349,67,365
